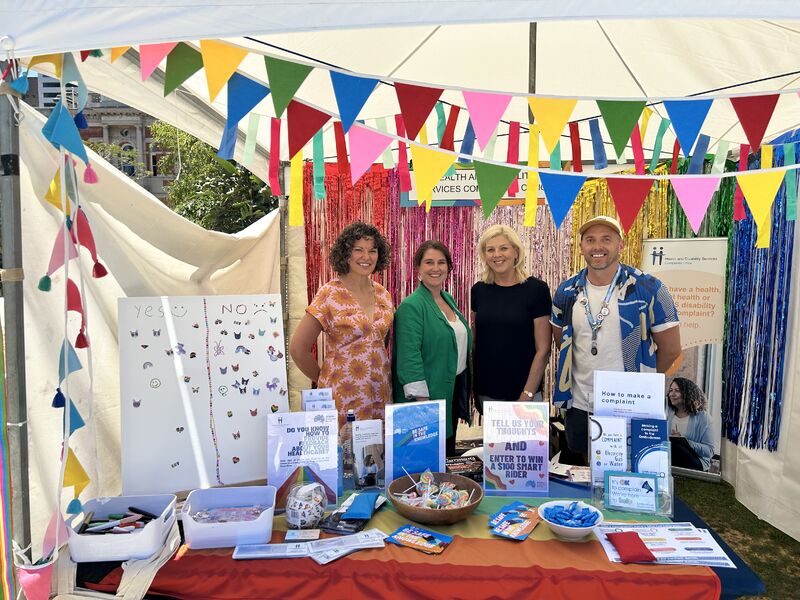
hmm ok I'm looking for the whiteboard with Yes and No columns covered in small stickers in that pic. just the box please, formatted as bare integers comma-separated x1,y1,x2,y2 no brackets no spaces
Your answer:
119,294,289,494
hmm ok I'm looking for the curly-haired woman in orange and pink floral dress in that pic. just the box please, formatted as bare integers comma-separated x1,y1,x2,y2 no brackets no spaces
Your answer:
289,222,394,427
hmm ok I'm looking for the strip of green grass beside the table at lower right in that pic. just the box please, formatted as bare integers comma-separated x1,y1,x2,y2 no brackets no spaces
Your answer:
675,477,800,600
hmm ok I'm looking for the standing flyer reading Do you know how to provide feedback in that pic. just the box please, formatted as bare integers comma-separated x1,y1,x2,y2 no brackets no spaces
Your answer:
267,411,339,510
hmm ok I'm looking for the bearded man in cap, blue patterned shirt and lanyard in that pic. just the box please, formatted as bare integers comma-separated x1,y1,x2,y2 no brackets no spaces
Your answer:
550,216,681,459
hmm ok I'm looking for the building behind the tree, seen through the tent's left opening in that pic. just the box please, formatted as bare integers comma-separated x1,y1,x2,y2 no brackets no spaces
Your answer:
23,75,174,201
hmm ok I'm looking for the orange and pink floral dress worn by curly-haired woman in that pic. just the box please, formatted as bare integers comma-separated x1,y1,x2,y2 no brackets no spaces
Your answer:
306,279,394,428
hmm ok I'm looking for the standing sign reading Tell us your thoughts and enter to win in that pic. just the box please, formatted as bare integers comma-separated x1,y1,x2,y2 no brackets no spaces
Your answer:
483,402,550,496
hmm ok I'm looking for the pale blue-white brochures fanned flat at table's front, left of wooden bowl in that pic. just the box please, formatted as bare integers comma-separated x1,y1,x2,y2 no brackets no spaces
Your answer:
233,529,386,565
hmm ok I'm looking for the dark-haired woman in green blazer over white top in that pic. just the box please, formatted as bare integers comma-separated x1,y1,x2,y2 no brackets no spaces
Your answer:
392,240,472,456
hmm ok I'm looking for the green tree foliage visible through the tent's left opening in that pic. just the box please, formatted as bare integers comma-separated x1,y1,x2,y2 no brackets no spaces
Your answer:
150,121,278,233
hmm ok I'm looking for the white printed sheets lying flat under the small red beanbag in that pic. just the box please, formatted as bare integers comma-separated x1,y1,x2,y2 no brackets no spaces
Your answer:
594,521,736,569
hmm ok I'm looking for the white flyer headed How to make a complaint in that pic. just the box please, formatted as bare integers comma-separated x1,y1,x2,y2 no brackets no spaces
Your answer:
594,371,667,419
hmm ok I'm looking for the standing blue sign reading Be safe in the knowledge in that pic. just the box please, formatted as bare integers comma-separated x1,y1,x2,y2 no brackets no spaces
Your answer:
385,400,446,484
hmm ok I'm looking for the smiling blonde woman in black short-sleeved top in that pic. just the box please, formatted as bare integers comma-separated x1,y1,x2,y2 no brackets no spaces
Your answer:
471,225,552,410
